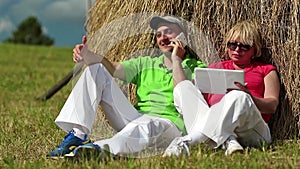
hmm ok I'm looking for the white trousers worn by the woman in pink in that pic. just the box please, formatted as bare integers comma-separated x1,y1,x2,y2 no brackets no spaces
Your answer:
174,81,271,147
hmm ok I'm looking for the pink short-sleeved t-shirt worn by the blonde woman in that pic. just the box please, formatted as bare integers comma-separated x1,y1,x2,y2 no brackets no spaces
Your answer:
206,60,276,123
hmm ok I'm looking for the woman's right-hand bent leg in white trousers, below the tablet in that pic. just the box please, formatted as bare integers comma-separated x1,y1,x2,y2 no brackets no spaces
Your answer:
201,91,271,147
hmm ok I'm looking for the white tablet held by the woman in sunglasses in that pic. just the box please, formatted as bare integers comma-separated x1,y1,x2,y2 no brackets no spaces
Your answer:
195,68,244,94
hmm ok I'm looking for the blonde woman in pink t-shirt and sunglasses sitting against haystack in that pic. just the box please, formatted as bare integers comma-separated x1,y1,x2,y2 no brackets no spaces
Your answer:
164,21,280,156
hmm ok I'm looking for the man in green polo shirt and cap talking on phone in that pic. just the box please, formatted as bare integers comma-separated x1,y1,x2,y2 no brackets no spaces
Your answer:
47,16,205,158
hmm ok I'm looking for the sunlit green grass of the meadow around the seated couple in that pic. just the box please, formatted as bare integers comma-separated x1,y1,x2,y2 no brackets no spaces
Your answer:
0,44,300,169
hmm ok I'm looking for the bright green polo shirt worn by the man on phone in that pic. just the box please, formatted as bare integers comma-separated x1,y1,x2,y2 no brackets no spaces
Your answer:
121,55,206,133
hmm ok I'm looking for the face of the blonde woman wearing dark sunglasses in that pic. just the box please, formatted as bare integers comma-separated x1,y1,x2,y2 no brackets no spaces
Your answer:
227,39,255,67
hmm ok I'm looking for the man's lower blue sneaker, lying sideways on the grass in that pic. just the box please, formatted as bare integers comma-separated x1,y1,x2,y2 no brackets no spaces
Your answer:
65,143,105,159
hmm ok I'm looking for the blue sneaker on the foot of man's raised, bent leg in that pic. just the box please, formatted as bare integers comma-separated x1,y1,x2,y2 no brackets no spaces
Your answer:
46,130,91,159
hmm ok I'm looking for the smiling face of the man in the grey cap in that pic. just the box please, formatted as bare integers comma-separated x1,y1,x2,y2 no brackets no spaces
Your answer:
156,23,182,53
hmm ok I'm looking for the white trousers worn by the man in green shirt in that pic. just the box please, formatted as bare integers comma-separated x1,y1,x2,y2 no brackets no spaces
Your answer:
55,64,182,155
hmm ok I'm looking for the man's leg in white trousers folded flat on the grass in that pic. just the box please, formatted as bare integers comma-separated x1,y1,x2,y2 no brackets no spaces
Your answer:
95,115,182,157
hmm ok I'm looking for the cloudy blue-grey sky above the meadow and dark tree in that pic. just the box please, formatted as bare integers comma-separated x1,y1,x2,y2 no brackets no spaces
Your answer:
0,0,95,47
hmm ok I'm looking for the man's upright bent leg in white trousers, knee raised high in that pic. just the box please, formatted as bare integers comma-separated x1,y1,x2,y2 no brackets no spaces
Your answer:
55,64,141,134
